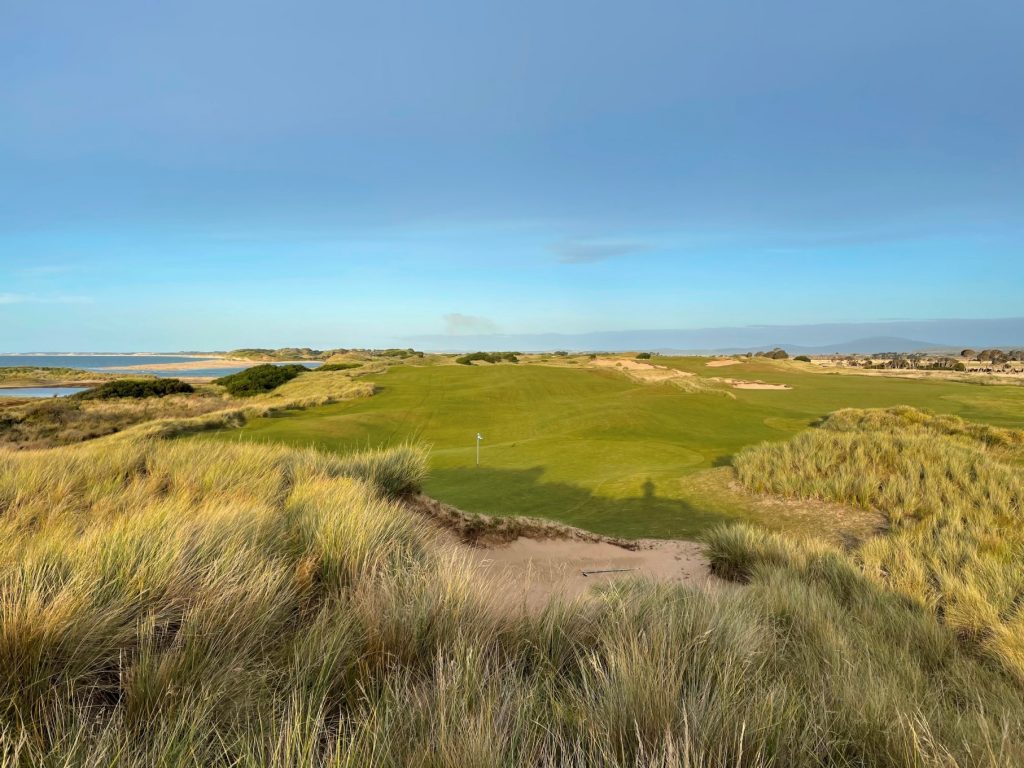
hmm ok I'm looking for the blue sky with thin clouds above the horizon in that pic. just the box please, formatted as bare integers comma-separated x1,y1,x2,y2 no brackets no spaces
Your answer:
0,0,1024,351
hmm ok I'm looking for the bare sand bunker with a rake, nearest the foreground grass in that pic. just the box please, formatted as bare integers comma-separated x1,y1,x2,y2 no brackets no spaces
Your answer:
464,538,722,609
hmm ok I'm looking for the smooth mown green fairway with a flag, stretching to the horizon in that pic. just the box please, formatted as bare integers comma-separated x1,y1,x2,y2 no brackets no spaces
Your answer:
205,358,1024,538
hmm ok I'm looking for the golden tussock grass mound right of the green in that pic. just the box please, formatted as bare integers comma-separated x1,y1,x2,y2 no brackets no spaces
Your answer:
734,409,1024,680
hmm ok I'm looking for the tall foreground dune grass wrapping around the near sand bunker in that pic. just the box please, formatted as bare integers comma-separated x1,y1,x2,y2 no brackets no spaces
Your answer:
0,439,1024,768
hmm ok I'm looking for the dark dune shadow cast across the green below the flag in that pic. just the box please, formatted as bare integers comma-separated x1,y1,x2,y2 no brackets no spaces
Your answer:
427,467,739,539
